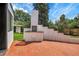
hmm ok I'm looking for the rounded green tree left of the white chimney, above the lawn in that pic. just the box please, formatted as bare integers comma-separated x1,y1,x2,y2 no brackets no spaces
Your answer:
14,9,31,27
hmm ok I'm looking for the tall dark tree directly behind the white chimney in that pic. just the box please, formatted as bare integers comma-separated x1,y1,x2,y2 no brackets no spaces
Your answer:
33,3,48,26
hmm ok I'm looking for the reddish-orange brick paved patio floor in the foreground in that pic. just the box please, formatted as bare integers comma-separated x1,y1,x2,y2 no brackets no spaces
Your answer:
5,41,79,56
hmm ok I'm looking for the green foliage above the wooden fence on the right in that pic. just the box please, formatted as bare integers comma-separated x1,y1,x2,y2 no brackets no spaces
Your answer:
54,14,79,32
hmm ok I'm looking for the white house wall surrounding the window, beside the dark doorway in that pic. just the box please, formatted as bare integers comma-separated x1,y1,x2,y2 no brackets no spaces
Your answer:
7,4,14,49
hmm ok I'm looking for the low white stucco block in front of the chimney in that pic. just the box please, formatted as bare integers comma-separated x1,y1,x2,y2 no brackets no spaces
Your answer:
24,32,43,42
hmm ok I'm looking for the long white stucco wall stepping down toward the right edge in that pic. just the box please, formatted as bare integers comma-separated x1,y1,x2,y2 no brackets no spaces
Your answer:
43,27,79,43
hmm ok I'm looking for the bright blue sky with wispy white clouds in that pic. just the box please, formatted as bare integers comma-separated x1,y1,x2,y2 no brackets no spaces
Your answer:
13,3,79,22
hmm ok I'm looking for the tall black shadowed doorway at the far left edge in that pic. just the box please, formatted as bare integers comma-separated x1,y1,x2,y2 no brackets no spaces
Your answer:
0,3,7,50
